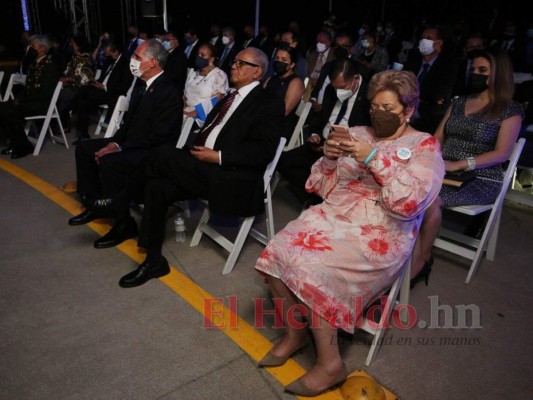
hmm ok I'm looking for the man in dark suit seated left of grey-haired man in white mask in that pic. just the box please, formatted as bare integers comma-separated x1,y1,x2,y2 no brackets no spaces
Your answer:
74,42,133,144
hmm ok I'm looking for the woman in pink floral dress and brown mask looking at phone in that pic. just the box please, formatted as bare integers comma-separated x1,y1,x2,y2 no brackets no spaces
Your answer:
256,71,444,396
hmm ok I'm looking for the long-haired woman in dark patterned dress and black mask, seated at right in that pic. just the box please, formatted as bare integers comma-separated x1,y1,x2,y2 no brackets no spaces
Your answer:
412,51,524,284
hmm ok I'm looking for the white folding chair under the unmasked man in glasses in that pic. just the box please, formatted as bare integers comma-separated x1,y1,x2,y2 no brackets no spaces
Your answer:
191,138,287,275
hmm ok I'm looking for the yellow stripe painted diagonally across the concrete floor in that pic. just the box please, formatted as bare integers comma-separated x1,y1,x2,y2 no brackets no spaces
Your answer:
0,159,342,400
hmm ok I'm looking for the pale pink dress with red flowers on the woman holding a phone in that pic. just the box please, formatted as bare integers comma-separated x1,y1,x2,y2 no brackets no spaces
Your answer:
255,127,444,333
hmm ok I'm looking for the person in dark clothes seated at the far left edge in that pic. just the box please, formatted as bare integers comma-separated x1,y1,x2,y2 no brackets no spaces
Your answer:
0,35,59,158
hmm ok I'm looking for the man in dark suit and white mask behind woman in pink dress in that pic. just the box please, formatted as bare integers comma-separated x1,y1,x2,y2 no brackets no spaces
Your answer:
404,27,457,134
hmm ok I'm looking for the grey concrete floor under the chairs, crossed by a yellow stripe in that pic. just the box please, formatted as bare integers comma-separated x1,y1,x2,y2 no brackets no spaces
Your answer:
0,137,533,400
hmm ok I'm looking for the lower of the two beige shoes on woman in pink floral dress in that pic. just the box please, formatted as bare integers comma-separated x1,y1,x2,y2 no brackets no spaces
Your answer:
285,361,348,397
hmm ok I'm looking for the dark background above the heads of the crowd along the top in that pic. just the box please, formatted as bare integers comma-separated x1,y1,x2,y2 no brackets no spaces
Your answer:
0,0,533,59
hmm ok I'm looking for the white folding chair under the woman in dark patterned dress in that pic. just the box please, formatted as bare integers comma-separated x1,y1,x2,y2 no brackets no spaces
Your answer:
434,138,525,283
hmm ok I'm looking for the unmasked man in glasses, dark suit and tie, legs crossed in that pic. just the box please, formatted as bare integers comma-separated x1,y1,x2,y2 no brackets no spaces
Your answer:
111,48,285,287
